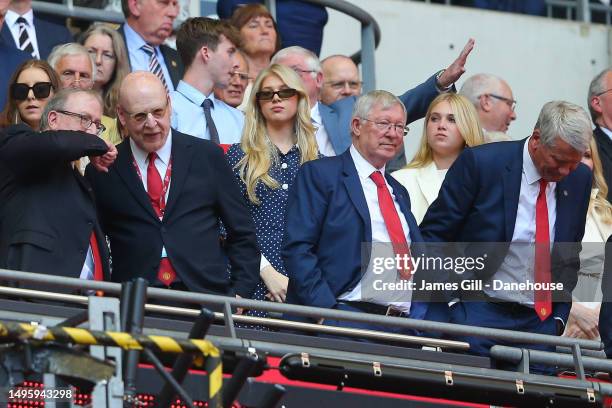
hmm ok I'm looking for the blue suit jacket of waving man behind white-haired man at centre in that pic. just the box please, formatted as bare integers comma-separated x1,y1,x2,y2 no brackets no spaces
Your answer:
319,75,439,172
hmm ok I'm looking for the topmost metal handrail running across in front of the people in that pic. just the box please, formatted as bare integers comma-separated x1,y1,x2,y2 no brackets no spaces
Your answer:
0,269,603,350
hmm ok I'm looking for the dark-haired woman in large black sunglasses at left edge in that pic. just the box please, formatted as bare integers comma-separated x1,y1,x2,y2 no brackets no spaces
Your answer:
0,60,60,130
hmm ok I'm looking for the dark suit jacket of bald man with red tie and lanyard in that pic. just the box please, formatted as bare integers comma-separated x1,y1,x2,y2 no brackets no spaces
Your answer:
86,130,260,297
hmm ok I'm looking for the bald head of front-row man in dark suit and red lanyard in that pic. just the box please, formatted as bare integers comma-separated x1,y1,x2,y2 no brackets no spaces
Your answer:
117,71,172,153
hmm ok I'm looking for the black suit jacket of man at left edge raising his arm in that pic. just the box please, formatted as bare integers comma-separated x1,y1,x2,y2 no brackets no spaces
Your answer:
0,125,110,279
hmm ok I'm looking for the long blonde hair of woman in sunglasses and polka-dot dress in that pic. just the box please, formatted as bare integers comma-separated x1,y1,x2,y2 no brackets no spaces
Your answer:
236,64,318,205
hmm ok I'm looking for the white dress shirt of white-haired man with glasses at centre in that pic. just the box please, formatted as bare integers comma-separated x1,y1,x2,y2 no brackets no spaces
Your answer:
338,145,412,313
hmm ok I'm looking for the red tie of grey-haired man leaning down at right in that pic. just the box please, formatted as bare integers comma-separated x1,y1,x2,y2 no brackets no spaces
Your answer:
534,179,552,320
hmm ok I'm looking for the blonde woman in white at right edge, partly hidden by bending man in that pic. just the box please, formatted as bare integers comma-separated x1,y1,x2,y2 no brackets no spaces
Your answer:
563,139,612,339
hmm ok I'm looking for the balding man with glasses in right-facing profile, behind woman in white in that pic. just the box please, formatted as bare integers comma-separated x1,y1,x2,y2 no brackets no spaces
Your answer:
459,74,516,142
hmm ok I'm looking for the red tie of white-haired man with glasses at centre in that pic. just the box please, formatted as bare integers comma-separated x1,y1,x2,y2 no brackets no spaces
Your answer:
370,171,413,280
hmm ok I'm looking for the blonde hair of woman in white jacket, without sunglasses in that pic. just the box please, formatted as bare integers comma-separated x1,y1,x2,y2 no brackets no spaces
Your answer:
406,93,484,169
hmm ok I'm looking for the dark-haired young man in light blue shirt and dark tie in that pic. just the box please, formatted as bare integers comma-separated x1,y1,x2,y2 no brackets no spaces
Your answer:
172,17,244,148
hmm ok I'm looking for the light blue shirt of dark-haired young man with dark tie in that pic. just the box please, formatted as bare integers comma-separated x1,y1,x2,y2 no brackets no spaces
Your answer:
170,81,244,144
